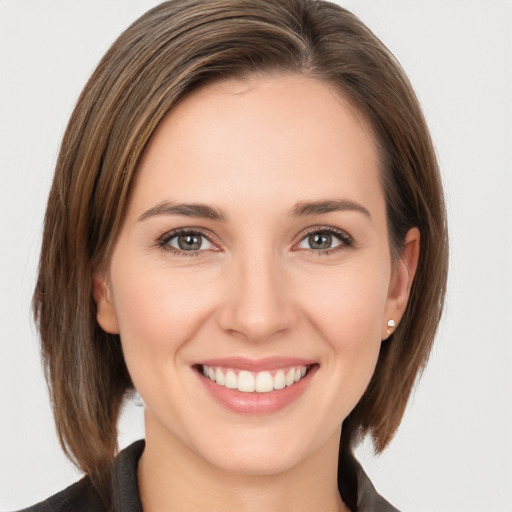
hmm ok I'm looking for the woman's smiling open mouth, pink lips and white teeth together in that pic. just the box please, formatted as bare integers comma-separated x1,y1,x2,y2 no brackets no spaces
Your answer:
194,358,319,415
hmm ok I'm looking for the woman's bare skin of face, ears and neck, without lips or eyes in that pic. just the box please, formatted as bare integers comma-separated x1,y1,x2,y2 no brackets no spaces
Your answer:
95,75,419,512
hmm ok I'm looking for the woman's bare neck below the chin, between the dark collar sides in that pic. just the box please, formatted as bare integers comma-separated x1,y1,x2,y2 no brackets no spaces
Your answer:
138,414,348,512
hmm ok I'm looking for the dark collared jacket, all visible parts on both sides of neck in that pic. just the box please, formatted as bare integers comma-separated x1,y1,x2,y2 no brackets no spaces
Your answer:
20,441,398,512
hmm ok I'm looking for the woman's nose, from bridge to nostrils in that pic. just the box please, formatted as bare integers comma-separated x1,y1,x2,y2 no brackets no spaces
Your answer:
218,247,297,341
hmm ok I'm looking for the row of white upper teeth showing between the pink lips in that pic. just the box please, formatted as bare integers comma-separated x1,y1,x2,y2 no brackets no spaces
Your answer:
202,365,308,393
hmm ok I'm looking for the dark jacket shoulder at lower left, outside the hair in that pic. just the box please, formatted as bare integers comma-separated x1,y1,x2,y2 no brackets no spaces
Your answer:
14,477,106,512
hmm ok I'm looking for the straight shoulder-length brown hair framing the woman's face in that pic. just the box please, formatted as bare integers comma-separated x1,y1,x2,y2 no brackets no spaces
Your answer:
33,0,448,504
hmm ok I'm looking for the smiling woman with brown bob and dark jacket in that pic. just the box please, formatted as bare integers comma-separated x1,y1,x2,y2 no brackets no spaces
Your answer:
20,0,447,512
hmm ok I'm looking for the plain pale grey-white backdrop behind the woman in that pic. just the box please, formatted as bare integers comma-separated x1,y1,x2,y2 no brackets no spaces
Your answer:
0,0,512,512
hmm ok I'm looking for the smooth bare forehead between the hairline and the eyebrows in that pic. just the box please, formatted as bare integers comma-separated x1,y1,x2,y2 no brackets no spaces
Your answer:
133,75,382,219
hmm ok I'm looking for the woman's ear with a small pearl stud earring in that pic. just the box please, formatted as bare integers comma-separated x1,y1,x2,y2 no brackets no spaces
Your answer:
382,228,420,340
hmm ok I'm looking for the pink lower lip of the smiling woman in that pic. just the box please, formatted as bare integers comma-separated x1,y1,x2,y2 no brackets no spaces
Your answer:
197,365,318,414
